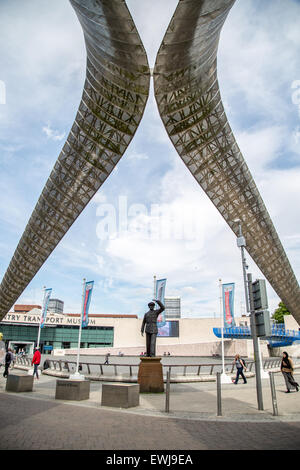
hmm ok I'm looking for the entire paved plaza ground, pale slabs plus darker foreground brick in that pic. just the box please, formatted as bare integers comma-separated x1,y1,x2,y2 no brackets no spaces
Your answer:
0,370,300,451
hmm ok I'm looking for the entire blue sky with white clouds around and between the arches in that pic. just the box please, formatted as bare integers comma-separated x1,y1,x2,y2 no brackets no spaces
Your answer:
0,0,300,317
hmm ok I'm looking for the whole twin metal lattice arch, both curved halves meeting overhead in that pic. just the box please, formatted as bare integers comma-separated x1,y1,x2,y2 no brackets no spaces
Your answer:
0,0,300,322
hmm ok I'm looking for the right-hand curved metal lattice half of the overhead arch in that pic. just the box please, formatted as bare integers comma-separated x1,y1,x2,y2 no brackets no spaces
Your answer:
154,0,300,323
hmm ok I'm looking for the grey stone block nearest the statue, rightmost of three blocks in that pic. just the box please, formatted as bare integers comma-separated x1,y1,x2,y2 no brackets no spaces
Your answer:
101,383,140,408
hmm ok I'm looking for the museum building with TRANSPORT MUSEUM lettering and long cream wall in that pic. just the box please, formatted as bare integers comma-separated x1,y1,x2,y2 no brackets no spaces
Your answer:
0,305,258,356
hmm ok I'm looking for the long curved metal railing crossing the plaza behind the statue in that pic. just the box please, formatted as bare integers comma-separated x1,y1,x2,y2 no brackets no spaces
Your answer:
16,357,288,378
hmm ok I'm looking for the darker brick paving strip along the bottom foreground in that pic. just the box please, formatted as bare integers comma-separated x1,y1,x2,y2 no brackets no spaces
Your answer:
0,393,300,450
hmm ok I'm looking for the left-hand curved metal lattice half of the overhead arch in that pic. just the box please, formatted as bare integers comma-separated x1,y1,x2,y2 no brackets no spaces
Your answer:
0,0,150,320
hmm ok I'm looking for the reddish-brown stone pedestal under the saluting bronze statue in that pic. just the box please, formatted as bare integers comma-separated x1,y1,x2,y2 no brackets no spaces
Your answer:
138,357,164,393
